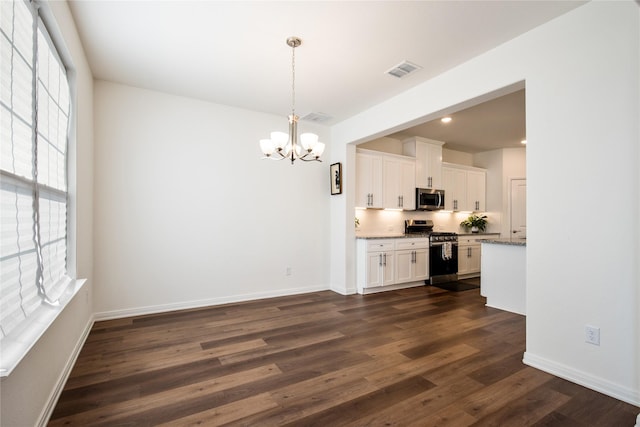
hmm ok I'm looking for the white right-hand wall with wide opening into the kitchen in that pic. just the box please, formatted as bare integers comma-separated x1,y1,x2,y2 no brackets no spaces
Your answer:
331,1,640,404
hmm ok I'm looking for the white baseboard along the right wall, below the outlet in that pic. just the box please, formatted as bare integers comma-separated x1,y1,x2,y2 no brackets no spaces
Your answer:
522,352,640,408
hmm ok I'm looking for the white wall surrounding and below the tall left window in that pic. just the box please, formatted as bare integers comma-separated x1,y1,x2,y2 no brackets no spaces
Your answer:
0,2,93,427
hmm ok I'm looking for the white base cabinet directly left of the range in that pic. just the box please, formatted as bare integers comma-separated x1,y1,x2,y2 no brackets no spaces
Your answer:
395,239,429,283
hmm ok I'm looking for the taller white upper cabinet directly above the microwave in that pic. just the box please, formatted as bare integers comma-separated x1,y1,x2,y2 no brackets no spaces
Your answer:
403,136,444,190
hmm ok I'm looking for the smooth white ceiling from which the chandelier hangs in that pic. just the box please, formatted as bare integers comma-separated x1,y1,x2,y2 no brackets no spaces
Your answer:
69,0,584,150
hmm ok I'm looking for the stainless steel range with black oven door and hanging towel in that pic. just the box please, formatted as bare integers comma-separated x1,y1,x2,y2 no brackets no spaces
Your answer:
404,219,458,285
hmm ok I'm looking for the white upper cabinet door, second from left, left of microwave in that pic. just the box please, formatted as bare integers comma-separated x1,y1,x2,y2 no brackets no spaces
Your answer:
382,155,416,210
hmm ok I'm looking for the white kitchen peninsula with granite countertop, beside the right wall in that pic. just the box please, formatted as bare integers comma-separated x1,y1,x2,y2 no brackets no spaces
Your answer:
480,239,527,315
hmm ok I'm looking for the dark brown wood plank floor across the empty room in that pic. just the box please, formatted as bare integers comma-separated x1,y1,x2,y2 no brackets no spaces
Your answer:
50,287,640,427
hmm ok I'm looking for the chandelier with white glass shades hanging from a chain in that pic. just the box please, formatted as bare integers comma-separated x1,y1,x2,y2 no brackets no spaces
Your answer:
260,37,324,164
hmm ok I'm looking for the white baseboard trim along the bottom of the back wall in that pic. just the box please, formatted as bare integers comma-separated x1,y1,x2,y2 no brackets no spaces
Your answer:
94,285,330,321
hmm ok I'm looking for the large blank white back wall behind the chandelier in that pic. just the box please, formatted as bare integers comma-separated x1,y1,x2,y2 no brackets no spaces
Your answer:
95,81,331,318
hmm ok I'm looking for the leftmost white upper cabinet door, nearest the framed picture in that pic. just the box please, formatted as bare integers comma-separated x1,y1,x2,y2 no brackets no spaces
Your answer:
356,152,383,208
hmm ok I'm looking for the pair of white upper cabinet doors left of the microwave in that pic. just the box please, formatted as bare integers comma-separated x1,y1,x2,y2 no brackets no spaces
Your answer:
356,150,416,210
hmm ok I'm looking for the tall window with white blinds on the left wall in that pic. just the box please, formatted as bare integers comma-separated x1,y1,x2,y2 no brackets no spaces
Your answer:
0,0,72,376
